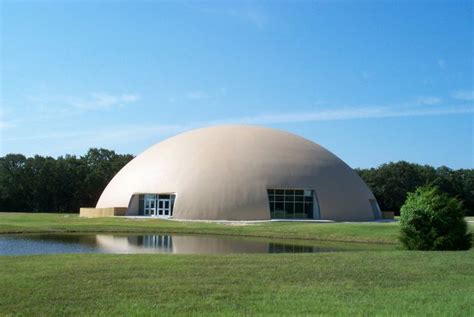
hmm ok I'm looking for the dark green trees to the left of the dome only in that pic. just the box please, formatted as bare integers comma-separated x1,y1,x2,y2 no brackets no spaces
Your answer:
0,149,133,212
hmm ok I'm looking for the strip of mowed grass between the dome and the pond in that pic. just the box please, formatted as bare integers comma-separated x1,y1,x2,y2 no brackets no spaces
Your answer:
0,213,404,244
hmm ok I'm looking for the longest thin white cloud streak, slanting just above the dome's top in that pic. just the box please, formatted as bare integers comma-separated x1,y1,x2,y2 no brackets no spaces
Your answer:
8,97,474,146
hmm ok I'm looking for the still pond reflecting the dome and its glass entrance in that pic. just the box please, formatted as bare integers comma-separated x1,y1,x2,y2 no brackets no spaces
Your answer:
0,234,386,255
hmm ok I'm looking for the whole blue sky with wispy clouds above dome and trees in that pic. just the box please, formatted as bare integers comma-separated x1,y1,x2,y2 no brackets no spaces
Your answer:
0,1,474,168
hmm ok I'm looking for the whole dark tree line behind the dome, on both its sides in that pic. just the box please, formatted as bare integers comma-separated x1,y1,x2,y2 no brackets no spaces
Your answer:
0,148,474,215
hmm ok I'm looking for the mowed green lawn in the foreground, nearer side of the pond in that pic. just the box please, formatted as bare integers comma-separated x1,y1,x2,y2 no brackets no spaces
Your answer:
0,251,474,316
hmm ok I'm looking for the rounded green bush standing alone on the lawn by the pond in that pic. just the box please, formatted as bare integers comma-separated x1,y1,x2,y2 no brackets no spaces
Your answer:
400,186,471,250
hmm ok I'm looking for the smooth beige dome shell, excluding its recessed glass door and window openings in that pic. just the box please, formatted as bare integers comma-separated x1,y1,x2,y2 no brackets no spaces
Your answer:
97,125,380,221
